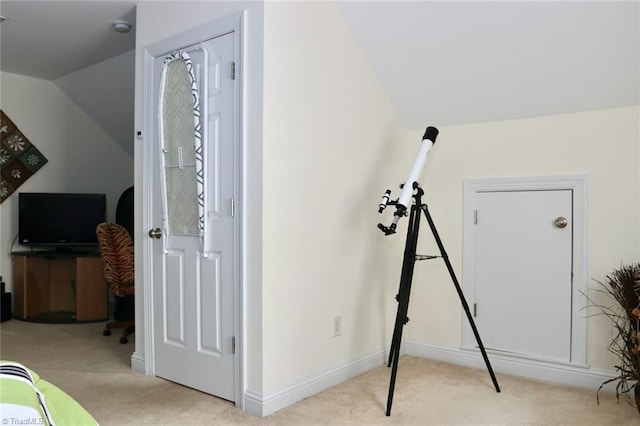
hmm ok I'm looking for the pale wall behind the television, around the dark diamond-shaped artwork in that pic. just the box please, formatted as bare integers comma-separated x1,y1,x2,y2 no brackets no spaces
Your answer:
0,73,133,289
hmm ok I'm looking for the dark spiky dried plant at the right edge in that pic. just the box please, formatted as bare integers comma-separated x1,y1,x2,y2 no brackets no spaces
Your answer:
597,263,640,413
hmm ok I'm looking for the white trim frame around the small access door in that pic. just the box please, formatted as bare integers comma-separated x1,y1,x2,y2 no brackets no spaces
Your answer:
461,175,589,367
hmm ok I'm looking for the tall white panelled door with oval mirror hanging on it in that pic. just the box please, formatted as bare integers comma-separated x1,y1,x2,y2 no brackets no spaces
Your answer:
150,32,238,401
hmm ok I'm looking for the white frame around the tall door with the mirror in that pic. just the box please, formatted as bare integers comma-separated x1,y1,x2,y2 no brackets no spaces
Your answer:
136,12,246,409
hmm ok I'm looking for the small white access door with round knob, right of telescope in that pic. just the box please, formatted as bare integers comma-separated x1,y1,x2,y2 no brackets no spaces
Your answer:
470,190,573,362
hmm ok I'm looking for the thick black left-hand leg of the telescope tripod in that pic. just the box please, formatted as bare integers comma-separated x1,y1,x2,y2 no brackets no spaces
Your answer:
387,204,420,416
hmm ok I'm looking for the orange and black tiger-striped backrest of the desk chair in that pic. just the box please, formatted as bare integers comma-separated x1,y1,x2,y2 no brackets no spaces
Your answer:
96,223,135,297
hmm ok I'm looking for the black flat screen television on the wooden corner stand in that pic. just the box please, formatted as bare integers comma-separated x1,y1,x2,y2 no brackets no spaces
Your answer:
18,192,107,250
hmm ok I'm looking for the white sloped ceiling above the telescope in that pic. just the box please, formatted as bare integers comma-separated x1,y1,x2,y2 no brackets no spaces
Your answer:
338,1,640,129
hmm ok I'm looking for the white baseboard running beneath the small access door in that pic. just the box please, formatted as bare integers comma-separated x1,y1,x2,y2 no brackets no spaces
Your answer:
402,342,615,391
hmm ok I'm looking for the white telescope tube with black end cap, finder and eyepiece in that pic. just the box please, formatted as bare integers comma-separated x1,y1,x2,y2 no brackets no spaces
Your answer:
378,127,438,235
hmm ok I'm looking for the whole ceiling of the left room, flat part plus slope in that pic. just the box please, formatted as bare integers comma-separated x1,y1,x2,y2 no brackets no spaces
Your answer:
0,0,136,157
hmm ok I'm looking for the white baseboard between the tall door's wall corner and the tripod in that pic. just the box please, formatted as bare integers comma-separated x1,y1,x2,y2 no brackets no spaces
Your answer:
244,350,385,417
